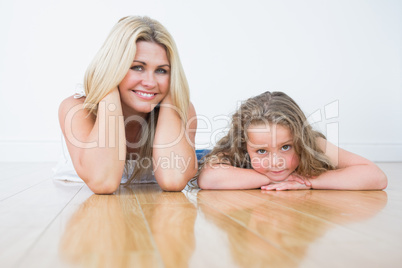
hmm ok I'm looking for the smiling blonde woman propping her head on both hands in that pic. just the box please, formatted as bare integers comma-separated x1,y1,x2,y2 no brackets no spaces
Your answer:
55,16,197,194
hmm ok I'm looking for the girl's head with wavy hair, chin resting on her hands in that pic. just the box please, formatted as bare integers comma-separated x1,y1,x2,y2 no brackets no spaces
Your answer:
200,92,334,181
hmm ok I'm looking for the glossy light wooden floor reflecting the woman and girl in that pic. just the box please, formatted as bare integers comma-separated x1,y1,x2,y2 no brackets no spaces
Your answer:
0,163,402,267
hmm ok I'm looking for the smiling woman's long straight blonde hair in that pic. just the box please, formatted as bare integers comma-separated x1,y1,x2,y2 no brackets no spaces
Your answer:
84,16,190,183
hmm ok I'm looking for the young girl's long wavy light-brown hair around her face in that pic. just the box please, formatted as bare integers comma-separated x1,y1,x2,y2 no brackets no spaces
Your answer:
196,91,335,181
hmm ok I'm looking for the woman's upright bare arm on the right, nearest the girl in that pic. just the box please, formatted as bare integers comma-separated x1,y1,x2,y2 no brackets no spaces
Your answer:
152,94,198,191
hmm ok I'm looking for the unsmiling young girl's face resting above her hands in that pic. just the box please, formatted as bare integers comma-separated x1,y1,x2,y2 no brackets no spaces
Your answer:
247,124,299,181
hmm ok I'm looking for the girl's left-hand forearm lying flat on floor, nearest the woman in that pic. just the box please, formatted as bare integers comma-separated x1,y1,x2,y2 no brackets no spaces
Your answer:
197,164,270,190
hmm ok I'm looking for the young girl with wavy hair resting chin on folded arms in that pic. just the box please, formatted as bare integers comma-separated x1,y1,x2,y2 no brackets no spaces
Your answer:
198,92,387,190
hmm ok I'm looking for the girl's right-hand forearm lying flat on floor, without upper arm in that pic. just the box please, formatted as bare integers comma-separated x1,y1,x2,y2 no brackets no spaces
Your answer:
310,164,387,190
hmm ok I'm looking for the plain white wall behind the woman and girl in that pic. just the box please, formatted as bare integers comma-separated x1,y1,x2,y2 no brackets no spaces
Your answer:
0,0,402,161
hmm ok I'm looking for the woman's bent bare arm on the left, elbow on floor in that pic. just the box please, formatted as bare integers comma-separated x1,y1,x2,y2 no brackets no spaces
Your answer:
59,88,126,194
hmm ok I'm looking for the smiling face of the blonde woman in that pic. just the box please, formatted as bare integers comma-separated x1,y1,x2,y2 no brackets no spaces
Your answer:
119,41,170,114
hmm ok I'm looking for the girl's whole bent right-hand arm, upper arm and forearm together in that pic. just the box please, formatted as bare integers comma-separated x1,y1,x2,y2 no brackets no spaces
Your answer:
310,138,388,190
